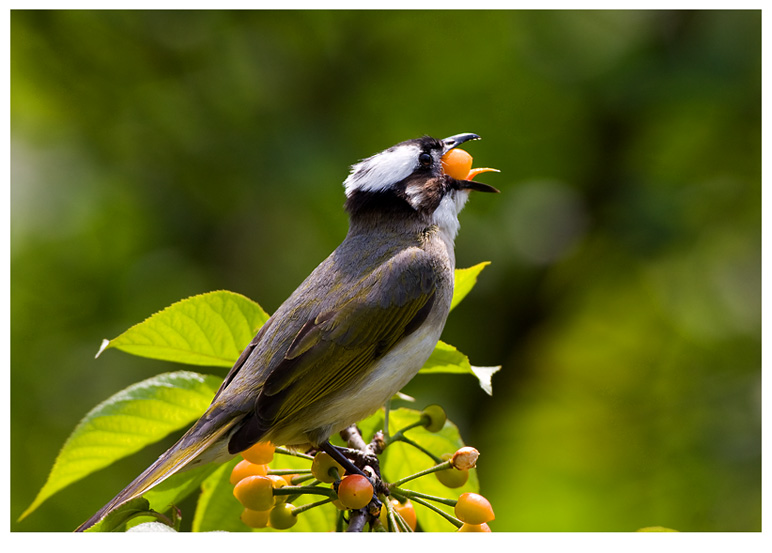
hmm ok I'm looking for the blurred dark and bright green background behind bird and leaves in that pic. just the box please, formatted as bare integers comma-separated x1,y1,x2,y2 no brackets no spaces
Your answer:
11,11,761,531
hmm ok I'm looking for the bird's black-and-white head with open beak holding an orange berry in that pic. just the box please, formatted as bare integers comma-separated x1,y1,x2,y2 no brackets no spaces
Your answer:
343,133,498,237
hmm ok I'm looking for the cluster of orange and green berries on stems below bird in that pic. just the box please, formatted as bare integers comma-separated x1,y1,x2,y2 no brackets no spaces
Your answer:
230,405,494,532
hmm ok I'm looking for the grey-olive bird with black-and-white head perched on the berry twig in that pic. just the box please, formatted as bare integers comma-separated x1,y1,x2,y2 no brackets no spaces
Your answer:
76,133,498,531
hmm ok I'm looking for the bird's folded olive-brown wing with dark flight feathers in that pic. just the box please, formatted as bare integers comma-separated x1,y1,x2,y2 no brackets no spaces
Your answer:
229,248,438,452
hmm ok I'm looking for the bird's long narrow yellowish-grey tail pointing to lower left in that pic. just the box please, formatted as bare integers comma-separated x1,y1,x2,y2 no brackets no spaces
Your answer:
75,418,239,532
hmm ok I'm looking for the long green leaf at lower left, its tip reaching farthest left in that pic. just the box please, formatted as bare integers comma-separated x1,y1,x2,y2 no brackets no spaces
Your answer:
19,371,222,520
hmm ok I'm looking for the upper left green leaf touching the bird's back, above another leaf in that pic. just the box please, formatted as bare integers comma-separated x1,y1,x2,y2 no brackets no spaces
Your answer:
97,290,268,367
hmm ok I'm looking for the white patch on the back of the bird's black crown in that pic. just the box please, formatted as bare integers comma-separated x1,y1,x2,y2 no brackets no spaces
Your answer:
343,145,420,197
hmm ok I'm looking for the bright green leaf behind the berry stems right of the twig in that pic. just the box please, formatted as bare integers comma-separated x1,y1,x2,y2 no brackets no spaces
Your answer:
358,407,480,532
